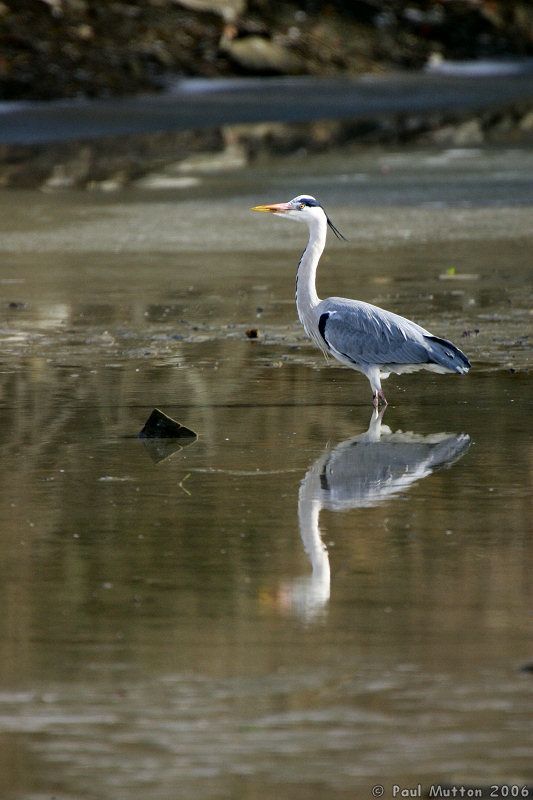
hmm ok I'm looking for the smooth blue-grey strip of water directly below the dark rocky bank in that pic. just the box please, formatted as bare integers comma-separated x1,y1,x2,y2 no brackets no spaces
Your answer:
0,69,533,145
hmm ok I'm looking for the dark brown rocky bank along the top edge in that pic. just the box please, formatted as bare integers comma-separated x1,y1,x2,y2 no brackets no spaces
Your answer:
0,0,533,100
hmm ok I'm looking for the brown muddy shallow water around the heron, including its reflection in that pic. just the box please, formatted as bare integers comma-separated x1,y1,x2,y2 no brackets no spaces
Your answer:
0,151,533,800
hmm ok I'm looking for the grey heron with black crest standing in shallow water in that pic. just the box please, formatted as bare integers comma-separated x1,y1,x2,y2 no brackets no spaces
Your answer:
251,194,471,408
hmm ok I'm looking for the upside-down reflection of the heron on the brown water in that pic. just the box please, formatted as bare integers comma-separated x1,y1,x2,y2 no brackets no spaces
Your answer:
285,409,470,621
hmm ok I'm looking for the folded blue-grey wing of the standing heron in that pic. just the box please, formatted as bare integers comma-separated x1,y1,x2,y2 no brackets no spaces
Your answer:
319,298,431,366
